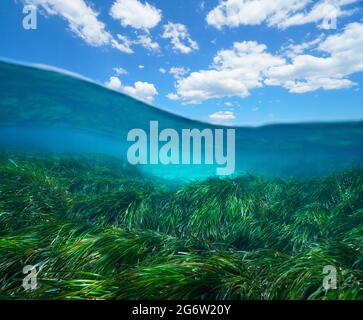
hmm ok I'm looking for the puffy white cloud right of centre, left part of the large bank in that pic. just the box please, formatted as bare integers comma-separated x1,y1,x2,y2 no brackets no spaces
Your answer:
172,41,285,103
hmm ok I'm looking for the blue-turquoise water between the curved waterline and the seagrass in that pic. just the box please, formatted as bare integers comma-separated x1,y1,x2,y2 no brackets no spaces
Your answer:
0,62,363,180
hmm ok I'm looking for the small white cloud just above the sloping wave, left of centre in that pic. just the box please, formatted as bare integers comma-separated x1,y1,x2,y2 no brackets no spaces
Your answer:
105,77,158,103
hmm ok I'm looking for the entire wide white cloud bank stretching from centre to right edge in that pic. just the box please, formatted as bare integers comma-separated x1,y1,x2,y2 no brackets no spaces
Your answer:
170,23,363,104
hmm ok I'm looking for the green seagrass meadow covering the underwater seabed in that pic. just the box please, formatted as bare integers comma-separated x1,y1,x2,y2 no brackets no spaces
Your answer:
0,152,363,299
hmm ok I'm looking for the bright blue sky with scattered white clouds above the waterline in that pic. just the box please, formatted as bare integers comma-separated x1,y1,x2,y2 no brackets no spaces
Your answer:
0,0,363,126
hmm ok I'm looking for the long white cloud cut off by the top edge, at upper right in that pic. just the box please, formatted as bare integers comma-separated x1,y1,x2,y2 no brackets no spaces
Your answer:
207,0,360,29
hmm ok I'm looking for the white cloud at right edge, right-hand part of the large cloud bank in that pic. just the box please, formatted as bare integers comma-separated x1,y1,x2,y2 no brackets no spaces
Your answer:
265,23,363,93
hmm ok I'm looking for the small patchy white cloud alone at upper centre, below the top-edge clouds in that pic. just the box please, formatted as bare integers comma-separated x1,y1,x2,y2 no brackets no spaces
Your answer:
162,22,198,54
